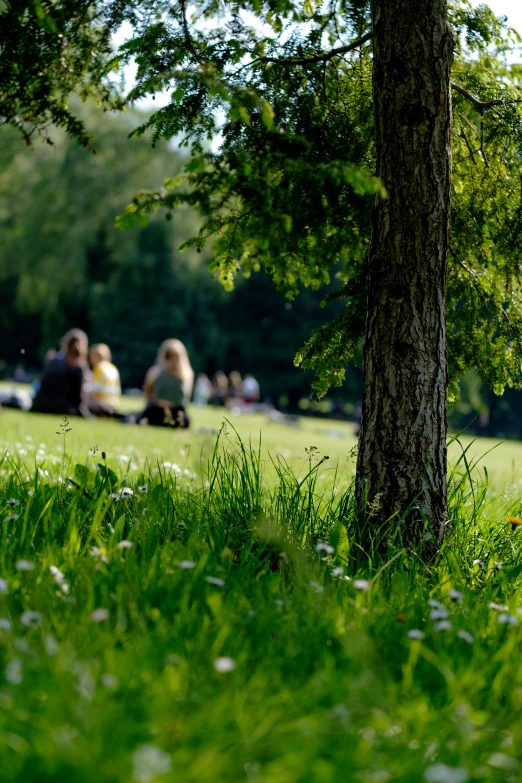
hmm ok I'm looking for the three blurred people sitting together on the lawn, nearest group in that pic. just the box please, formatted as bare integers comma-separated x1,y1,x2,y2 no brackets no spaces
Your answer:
31,329,194,427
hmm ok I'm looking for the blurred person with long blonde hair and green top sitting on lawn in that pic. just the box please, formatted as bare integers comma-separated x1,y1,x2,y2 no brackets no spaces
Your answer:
138,339,194,427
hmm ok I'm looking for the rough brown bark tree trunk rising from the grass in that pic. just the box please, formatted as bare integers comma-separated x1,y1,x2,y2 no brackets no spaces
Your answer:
357,0,453,548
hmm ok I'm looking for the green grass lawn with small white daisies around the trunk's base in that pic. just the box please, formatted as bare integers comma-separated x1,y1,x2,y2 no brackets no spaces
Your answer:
0,409,522,783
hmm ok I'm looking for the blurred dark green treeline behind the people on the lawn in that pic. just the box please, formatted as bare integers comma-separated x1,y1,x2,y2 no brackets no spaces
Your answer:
0,104,522,437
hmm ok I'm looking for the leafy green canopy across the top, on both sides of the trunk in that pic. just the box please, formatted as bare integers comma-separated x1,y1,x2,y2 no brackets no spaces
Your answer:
4,0,522,404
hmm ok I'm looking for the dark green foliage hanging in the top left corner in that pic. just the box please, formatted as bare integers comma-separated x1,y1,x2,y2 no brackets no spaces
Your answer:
0,0,122,146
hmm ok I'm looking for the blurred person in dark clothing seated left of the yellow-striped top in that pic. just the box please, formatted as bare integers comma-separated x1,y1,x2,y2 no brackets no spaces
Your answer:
31,329,90,417
